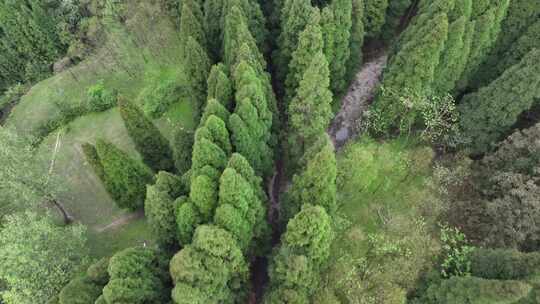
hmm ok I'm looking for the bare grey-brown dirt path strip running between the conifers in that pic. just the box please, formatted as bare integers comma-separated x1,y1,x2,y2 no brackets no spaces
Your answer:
328,53,387,148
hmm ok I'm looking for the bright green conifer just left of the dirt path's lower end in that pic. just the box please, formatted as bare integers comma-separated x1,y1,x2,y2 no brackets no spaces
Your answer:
288,52,332,159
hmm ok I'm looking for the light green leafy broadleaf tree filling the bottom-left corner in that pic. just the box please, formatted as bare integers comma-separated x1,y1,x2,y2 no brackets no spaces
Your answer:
0,211,87,304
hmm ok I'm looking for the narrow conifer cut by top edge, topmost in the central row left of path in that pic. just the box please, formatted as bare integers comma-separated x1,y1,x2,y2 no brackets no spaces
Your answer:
275,0,313,82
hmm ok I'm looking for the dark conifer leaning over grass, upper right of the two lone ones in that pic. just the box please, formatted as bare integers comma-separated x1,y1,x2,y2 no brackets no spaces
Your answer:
118,98,174,171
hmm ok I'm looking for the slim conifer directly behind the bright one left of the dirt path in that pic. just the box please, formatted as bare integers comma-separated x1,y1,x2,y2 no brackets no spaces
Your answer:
285,9,324,100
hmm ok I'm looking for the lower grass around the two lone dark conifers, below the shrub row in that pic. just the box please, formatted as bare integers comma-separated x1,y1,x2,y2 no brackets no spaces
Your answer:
40,101,194,256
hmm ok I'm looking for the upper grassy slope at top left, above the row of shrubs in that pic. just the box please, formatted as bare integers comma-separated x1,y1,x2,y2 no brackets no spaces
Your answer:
7,1,183,135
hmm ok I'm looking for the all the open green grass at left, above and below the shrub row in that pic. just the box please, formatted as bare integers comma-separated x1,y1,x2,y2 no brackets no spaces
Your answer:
7,1,195,257
